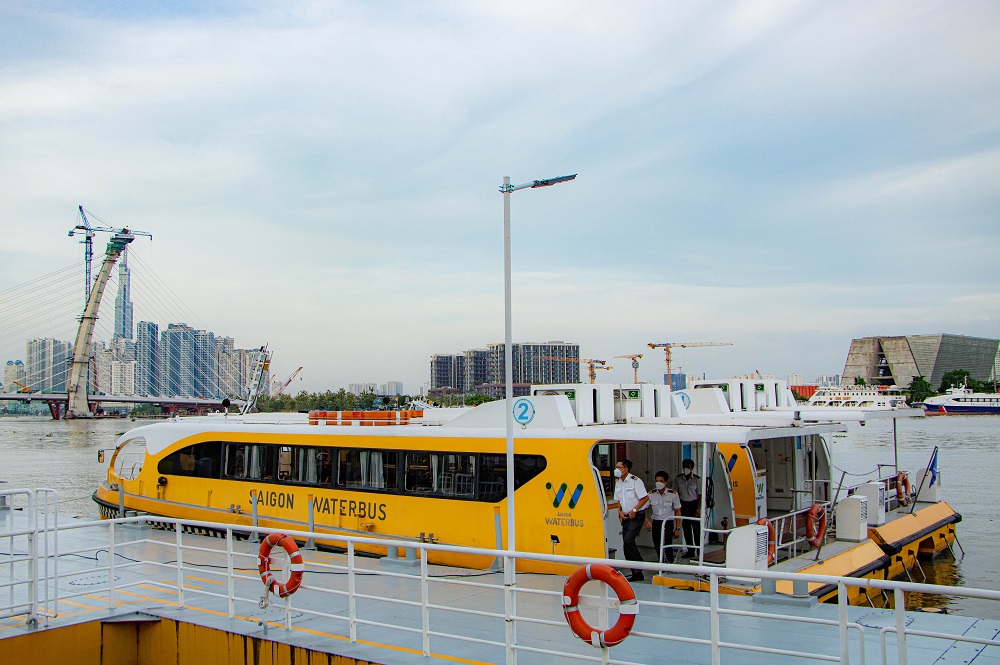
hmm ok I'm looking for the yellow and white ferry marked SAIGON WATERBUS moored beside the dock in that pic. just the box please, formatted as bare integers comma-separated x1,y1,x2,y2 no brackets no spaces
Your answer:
94,384,959,593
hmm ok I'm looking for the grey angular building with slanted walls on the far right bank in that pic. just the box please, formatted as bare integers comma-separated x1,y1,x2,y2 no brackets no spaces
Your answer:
841,334,1000,388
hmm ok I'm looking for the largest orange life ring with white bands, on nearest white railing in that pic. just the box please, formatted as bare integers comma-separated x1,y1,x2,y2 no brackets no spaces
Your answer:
563,563,639,648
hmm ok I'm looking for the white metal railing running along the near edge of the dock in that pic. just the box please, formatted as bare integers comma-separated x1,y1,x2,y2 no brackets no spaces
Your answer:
0,490,1000,665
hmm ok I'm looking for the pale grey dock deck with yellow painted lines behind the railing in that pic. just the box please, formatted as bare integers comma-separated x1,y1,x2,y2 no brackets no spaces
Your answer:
0,510,1000,665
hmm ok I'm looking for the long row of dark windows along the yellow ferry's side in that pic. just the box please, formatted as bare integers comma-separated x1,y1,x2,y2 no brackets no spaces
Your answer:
157,441,546,502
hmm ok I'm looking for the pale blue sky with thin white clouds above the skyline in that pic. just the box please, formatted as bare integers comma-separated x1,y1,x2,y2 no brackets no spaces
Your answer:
0,0,1000,392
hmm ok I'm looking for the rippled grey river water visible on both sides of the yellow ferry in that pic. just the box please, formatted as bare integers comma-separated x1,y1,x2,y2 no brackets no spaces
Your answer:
0,415,1000,619
